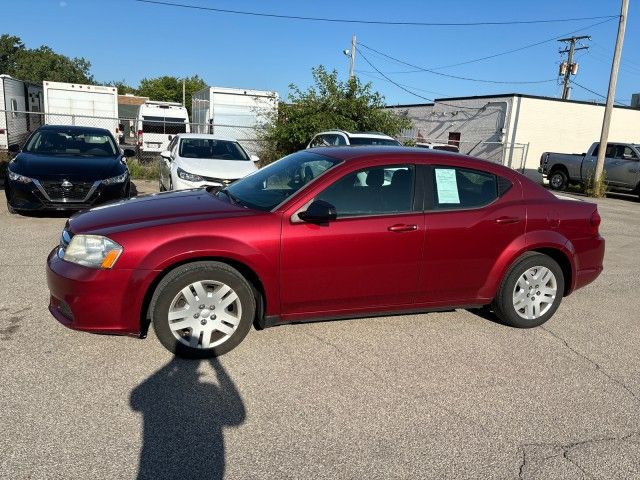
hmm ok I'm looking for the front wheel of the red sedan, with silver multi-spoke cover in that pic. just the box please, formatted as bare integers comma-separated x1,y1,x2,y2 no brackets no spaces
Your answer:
150,262,256,358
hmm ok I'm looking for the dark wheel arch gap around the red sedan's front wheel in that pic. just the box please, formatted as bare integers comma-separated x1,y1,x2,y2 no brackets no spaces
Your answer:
139,255,267,338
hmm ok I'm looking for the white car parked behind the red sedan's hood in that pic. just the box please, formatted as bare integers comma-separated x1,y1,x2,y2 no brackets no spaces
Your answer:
160,133,259,191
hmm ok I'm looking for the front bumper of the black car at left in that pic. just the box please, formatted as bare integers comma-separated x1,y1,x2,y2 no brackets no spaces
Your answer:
5,178,130,211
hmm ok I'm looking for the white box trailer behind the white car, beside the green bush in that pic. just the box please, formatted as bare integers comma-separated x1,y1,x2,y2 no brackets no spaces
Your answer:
191,87,278,154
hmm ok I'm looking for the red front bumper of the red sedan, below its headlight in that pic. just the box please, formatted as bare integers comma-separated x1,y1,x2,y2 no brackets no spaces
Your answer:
47,247,155,335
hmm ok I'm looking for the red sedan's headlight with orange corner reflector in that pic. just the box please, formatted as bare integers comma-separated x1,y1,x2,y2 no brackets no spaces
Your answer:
60,235,122,268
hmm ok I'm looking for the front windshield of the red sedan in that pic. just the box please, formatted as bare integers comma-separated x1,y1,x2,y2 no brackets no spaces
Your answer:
216,151,341,211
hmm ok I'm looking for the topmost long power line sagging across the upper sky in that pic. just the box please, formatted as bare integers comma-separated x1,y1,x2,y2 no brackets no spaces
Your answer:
136,0,618,27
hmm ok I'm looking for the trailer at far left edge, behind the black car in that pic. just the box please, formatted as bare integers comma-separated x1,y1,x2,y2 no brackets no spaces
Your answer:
0,75,42,150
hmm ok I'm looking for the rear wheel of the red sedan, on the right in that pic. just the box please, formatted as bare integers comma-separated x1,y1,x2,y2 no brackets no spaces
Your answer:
493,252,564,328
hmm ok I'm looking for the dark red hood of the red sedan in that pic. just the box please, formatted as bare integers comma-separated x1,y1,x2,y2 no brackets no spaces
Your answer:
69,189,263,233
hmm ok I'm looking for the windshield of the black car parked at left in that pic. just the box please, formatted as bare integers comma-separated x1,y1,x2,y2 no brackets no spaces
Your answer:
24,129,117,157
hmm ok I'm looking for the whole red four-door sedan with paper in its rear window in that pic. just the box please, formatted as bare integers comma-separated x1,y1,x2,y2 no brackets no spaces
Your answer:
47,147,604,357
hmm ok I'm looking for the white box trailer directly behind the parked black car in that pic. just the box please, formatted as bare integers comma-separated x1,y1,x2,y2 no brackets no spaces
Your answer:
42,80,119,139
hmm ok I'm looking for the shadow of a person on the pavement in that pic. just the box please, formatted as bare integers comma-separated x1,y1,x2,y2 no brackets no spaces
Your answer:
129,357,246,479
